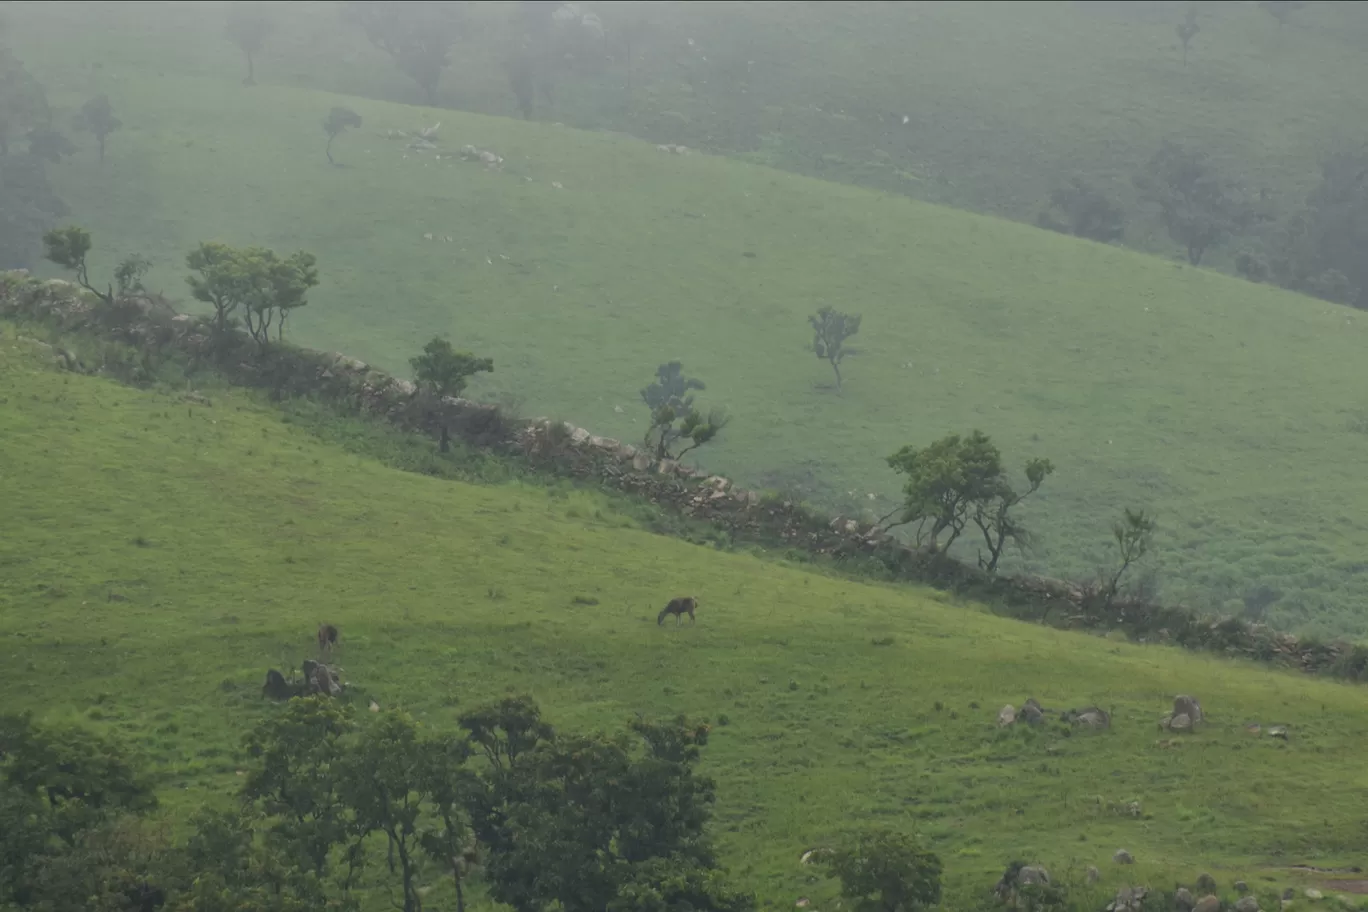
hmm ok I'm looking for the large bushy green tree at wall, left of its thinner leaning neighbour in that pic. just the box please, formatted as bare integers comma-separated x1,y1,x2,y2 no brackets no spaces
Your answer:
886,431,1003,551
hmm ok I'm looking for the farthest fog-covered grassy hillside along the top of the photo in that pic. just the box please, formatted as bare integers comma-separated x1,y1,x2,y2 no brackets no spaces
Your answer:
10,0,1368,263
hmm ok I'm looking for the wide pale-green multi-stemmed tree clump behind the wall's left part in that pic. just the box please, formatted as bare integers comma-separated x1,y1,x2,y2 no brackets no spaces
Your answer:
186,242,319,344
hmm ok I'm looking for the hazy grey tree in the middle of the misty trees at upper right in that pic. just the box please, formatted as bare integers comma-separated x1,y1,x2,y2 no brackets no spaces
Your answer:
1135,141,1249,265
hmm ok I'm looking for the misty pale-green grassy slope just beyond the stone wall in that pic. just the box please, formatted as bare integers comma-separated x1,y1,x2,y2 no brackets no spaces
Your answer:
8,57,1368,636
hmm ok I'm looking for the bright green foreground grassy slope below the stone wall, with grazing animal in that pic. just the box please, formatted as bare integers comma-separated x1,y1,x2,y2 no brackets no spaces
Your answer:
8,330,1368,909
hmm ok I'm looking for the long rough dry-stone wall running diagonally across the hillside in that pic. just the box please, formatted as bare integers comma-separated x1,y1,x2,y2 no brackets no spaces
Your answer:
0,272,1368,681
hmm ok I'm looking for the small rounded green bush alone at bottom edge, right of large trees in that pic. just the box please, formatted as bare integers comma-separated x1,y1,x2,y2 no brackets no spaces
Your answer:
826,830,941,912
